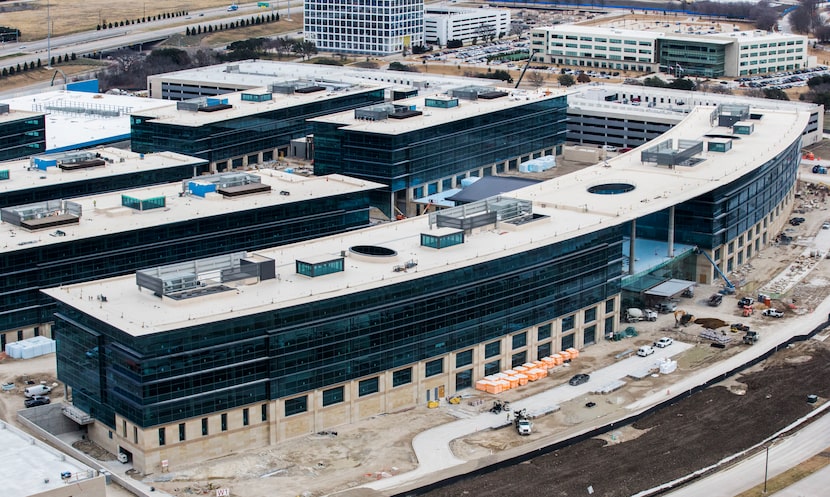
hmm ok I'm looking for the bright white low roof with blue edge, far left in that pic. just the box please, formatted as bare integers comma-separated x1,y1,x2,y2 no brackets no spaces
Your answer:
3,90,171,152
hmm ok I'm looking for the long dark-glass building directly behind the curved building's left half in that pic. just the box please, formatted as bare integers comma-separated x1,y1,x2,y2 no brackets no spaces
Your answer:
0,172,380,345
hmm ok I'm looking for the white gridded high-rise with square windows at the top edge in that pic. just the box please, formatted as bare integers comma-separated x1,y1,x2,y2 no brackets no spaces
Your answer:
303,0,424,55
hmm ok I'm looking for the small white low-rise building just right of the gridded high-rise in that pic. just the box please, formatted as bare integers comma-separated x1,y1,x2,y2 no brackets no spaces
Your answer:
424,5,510,46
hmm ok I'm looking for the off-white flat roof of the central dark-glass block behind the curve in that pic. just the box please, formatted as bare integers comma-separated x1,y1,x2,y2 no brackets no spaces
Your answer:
309,85,571,135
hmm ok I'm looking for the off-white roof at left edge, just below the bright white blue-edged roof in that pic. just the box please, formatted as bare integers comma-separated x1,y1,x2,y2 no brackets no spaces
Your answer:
0,147,207,195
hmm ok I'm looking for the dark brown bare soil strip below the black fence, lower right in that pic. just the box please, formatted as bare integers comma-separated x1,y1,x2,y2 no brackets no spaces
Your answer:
424,341,830,497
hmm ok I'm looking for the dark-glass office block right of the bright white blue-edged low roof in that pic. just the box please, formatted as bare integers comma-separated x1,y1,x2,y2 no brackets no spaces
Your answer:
130,81,384,171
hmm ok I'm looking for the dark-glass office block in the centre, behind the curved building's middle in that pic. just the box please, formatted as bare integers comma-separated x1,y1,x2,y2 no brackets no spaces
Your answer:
311,86,567,217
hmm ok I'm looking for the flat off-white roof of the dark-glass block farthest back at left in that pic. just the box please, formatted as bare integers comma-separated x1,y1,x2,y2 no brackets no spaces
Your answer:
133,82,388,127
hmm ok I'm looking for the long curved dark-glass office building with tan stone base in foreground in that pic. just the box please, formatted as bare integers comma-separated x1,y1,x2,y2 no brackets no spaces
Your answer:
46,102,809,473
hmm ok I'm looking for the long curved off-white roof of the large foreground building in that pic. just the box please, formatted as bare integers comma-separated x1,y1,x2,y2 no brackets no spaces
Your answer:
46,107,809,335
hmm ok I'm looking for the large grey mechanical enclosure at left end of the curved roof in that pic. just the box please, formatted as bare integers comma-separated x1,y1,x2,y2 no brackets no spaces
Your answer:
135,252,276,300
